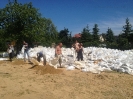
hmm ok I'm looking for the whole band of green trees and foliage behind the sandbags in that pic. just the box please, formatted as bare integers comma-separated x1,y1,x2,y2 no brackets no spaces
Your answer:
0,0,133,51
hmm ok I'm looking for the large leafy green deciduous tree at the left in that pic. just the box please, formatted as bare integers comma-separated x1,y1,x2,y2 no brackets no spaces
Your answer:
0,0,58,51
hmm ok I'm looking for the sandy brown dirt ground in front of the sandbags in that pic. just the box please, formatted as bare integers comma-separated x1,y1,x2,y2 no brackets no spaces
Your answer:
0,60,133,99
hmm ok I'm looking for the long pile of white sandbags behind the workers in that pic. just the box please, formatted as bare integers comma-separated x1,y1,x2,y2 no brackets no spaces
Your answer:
17,47,133,75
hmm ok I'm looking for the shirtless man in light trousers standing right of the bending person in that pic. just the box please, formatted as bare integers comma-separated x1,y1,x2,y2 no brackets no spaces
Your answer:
55,43,62,67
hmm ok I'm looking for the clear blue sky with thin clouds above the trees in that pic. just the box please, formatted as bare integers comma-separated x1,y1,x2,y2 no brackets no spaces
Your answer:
0,0,133,35
